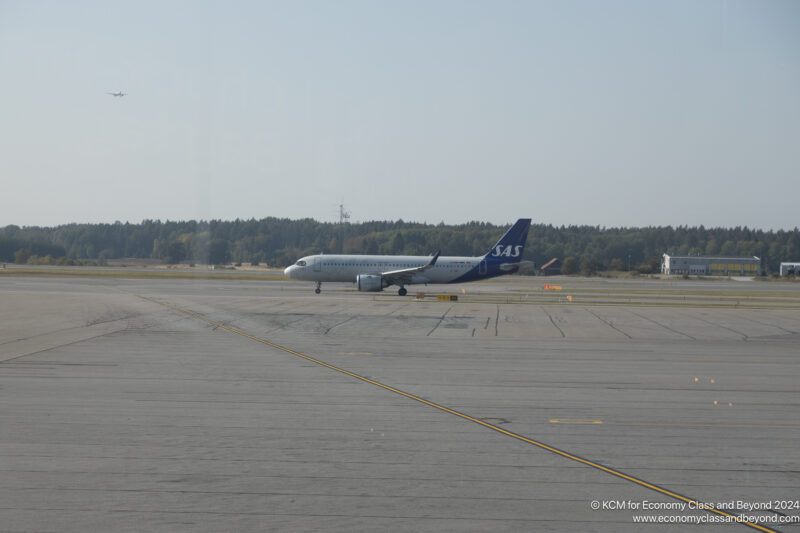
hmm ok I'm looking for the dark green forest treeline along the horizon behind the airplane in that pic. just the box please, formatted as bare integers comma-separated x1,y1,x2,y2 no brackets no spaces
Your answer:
0,218,800,272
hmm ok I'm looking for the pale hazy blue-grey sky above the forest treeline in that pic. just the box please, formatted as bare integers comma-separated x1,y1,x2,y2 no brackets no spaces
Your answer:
0,0,800,230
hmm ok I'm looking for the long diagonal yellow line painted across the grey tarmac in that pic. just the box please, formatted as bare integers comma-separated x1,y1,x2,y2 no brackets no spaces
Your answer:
138,295,778,533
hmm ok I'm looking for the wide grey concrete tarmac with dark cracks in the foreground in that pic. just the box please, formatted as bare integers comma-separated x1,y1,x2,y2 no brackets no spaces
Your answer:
0,277,800,531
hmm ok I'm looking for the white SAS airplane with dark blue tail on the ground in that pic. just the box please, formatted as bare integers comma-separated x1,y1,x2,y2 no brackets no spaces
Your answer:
283,218,532,296
